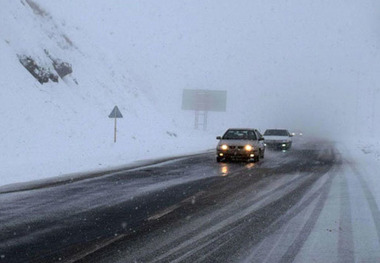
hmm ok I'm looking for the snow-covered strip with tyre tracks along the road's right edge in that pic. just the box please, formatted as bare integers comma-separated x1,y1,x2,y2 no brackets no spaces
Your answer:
295,144,380,262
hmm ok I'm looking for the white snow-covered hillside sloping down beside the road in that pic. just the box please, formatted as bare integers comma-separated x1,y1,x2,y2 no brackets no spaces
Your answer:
0,0,215,185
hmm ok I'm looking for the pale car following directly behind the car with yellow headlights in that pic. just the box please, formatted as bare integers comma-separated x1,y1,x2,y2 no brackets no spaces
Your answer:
264,129,293,150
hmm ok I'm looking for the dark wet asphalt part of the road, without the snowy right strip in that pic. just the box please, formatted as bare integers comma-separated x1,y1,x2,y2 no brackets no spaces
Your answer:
0,141,340,262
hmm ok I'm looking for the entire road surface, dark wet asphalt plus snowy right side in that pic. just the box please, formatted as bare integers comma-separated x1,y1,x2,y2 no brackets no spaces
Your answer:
0,140,380,262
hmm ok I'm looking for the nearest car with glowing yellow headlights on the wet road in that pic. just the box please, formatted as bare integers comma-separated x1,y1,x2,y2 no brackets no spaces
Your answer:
216,129,265,162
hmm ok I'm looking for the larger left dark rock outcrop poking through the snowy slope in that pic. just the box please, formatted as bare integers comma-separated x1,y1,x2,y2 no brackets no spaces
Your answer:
18,55,58,84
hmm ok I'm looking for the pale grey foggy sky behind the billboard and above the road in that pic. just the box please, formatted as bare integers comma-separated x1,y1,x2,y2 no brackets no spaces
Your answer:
47,0,380,139
